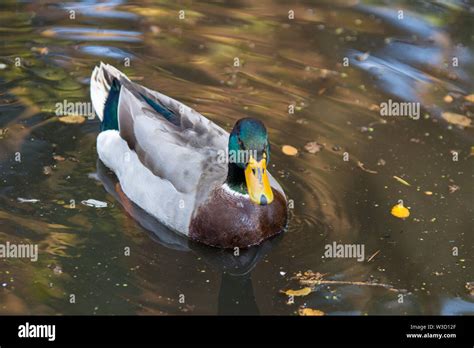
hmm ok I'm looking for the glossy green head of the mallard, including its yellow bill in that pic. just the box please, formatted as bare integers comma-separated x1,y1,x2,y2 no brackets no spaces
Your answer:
227,118,273,205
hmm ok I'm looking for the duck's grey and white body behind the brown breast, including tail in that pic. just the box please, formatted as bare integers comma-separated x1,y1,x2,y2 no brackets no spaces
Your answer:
91,64,228,234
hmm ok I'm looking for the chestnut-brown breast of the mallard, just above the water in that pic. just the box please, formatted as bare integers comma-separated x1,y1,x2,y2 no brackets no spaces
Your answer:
189,187,288,248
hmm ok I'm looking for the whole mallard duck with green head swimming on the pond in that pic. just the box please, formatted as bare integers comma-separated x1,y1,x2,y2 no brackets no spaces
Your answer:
90,63,288,248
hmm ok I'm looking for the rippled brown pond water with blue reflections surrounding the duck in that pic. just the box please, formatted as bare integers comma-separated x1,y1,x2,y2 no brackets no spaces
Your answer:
0,0,474,315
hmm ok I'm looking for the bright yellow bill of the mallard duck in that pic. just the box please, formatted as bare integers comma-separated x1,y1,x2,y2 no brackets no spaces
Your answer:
245,156,273,205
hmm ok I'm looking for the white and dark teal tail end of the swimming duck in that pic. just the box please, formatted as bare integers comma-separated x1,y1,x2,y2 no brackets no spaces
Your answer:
90,62,130,124
